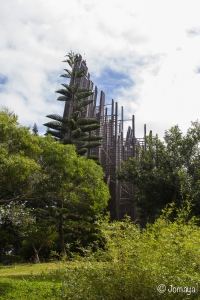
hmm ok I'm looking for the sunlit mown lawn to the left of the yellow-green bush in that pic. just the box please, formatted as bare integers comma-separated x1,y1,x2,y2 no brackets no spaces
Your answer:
0,261,107,300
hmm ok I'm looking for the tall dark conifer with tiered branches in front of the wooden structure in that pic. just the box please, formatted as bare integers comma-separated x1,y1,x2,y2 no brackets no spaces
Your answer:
44,52,102,160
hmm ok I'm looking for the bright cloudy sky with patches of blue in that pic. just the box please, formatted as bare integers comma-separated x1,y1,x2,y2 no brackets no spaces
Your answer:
0,0,200,139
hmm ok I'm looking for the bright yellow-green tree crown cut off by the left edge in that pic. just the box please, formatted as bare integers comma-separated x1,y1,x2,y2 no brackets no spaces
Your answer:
0,109,42,204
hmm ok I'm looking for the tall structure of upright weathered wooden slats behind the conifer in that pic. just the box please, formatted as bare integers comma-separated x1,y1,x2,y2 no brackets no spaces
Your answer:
63,56,146,220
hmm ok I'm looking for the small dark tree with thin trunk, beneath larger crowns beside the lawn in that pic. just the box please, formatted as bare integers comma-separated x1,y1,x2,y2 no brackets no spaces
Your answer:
0,202,57,263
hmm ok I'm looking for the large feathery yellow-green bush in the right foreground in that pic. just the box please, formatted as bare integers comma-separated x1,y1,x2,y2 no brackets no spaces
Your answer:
55,202,200,300
